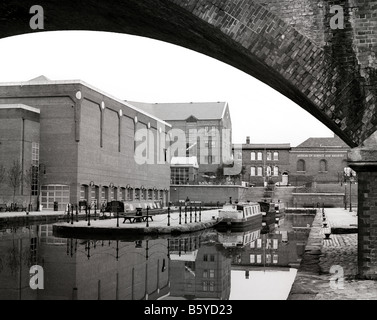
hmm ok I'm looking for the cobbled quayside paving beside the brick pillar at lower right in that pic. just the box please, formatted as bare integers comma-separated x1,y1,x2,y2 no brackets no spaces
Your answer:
288,208,377,300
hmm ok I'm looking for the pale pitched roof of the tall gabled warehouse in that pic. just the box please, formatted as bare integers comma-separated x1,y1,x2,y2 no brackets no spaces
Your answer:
127,101,227,121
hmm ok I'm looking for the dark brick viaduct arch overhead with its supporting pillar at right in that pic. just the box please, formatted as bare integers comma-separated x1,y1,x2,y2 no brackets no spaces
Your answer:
0,0,377,278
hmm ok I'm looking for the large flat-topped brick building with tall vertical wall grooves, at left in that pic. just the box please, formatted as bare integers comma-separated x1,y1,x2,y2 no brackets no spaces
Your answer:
0,77,171,210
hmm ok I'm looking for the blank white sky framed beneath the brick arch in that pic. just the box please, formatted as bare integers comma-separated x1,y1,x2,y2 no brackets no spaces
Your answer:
0,31,333,146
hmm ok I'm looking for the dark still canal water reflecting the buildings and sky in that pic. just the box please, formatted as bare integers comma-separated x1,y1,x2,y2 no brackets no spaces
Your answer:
0,214,314,300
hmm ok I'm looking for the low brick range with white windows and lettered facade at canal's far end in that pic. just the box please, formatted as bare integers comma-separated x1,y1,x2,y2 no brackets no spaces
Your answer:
238,136,349,186
